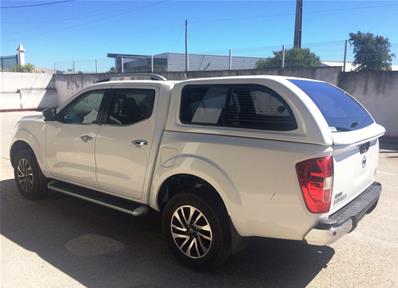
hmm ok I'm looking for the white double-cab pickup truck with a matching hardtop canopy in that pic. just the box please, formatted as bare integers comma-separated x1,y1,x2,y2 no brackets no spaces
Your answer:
10,75,385,268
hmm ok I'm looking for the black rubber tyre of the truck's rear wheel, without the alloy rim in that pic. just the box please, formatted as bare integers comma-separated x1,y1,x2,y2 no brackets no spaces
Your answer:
162,193,230,270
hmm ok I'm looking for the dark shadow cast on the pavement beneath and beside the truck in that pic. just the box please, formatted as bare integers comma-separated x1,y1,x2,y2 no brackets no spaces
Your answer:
0,180,334,288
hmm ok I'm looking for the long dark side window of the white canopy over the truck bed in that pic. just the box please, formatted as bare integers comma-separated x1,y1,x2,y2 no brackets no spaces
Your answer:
180,84,297,131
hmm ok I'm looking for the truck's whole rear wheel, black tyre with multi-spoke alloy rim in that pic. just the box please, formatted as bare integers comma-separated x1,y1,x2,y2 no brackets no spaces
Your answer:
162,193,231,270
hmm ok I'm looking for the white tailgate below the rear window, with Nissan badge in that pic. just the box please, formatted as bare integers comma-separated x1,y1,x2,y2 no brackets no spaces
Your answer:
329,124,384,214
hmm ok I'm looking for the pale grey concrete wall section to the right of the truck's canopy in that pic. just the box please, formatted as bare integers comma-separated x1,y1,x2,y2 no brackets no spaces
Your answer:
339,71,398,137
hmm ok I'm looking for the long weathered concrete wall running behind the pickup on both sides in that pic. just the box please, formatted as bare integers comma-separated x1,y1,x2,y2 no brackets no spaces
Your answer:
0,67,398,137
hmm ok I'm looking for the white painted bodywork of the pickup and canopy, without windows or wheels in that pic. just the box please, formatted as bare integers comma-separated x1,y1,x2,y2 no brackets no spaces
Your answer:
10,76,384,240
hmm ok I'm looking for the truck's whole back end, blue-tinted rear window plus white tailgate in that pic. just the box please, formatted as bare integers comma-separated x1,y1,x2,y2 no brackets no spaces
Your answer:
290,79,385,213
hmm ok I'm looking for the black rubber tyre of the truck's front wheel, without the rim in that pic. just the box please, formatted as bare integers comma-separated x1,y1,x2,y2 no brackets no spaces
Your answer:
14,150,47,200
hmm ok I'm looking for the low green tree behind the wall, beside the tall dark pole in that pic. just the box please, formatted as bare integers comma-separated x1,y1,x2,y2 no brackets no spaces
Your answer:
256,48,321,69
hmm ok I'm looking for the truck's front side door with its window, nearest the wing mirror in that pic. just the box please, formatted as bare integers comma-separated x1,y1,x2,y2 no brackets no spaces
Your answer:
46,90,106,187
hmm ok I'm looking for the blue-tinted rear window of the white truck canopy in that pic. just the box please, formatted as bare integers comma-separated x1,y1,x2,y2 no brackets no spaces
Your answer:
289,79,374,132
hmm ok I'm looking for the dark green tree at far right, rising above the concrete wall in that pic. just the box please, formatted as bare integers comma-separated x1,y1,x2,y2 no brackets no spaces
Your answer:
349,31,395,71
